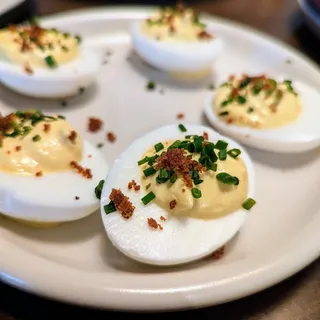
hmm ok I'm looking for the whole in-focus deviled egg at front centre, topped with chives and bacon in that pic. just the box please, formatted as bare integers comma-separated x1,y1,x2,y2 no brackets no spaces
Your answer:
101,125,255,265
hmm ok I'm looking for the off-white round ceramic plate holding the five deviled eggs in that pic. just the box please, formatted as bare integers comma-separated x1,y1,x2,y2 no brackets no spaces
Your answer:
0,7,320,310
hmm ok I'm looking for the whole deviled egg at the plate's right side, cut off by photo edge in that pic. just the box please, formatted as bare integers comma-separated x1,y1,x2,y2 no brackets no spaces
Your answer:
205,75,320,153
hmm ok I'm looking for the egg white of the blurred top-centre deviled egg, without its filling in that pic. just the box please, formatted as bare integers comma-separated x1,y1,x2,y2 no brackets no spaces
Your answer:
130,21,222,72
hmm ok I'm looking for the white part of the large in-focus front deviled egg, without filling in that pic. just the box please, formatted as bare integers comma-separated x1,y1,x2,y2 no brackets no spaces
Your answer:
101,125,254,266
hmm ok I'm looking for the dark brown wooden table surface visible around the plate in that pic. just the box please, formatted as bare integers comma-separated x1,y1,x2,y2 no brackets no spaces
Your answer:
0,0,320,320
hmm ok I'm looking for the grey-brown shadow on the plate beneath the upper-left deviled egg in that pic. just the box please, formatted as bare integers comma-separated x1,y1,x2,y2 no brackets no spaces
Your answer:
0,83,99,113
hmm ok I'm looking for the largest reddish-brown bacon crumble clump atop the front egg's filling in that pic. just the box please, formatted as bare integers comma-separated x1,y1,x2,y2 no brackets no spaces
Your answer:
154,149,206,188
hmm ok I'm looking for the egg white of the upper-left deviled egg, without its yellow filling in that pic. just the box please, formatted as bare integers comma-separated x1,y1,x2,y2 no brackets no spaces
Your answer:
0,46,100,98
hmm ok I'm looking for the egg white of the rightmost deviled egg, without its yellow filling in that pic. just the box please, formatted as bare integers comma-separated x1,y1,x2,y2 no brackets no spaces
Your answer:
204,82,320,153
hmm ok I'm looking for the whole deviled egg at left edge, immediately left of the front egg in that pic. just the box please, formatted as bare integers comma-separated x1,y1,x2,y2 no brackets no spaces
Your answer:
0,110,108,226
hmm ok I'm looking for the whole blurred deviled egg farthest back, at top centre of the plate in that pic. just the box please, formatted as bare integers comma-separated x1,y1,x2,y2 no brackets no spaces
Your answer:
130,5,222,79
